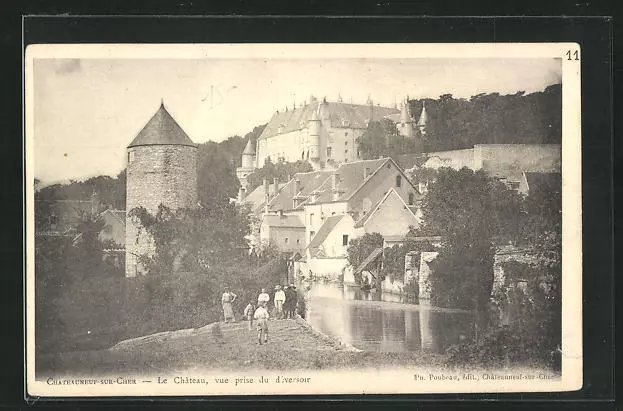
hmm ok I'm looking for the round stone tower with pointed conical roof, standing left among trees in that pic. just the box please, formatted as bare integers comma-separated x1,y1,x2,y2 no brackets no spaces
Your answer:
125,104,197,277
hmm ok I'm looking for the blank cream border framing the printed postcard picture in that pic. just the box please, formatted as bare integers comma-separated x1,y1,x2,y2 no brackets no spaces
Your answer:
24,43,582,397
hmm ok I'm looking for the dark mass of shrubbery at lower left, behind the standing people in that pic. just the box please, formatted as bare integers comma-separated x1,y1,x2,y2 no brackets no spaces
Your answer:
35,233,285,354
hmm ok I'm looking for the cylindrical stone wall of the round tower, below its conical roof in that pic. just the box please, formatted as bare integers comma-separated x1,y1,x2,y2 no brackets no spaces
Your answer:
126,145,197,277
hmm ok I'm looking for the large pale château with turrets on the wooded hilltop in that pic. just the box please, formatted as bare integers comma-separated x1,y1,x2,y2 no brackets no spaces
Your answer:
236,97,428,195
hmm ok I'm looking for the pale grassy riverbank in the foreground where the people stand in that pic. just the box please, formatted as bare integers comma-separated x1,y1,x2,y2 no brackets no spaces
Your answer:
37,318,443,376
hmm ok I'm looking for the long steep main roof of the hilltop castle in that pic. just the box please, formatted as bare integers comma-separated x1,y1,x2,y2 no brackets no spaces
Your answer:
259,102,400,140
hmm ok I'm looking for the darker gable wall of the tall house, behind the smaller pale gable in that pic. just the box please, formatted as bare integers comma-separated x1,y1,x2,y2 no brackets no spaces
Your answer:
348,161,416,217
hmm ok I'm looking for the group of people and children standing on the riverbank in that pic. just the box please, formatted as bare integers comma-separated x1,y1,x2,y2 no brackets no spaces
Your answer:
221,284,299,345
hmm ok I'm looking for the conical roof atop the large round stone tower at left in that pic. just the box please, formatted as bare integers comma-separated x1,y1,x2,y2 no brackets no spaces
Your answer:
128,103,197,148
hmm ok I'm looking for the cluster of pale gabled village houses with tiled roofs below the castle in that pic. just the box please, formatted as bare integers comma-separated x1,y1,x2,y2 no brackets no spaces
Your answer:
260,158,422,277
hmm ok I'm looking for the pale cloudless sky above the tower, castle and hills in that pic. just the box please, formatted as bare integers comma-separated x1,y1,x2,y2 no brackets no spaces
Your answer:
32,57,562,184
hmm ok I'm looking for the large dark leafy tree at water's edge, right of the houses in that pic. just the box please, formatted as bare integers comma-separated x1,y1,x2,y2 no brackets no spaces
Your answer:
422,168,521,328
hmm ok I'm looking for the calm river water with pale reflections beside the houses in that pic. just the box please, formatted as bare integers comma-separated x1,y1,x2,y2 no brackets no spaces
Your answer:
306,283,473,352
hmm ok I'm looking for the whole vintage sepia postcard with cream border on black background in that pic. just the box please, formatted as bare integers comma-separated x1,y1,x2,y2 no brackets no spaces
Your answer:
25,44,582,397
